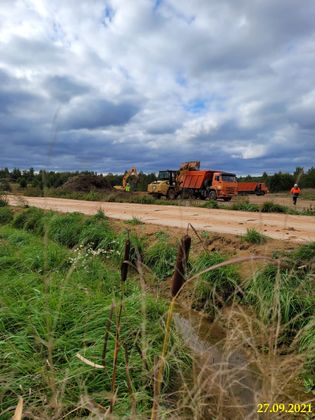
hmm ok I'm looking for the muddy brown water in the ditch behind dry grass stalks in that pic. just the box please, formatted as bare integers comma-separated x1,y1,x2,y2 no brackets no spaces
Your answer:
174,306,260,419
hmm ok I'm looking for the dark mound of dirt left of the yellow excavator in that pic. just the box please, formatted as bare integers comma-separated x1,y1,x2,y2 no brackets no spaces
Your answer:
62,175,112,192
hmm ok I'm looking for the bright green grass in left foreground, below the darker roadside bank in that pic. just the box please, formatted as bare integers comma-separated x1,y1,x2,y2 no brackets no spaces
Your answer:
0,223,191,419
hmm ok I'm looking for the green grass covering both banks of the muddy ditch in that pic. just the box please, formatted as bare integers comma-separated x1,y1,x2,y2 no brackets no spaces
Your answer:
0,206,315,418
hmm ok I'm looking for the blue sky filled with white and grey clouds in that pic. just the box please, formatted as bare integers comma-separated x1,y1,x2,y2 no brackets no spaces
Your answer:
0,0,315,175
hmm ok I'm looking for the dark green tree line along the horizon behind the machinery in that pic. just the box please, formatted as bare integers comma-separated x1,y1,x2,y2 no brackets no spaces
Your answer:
0,167,315,192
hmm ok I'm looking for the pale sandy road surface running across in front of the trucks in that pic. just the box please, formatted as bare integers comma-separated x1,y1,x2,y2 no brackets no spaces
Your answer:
9,196,315,242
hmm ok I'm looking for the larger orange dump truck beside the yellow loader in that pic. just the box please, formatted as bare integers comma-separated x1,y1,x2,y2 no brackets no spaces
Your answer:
178,170,237,201
